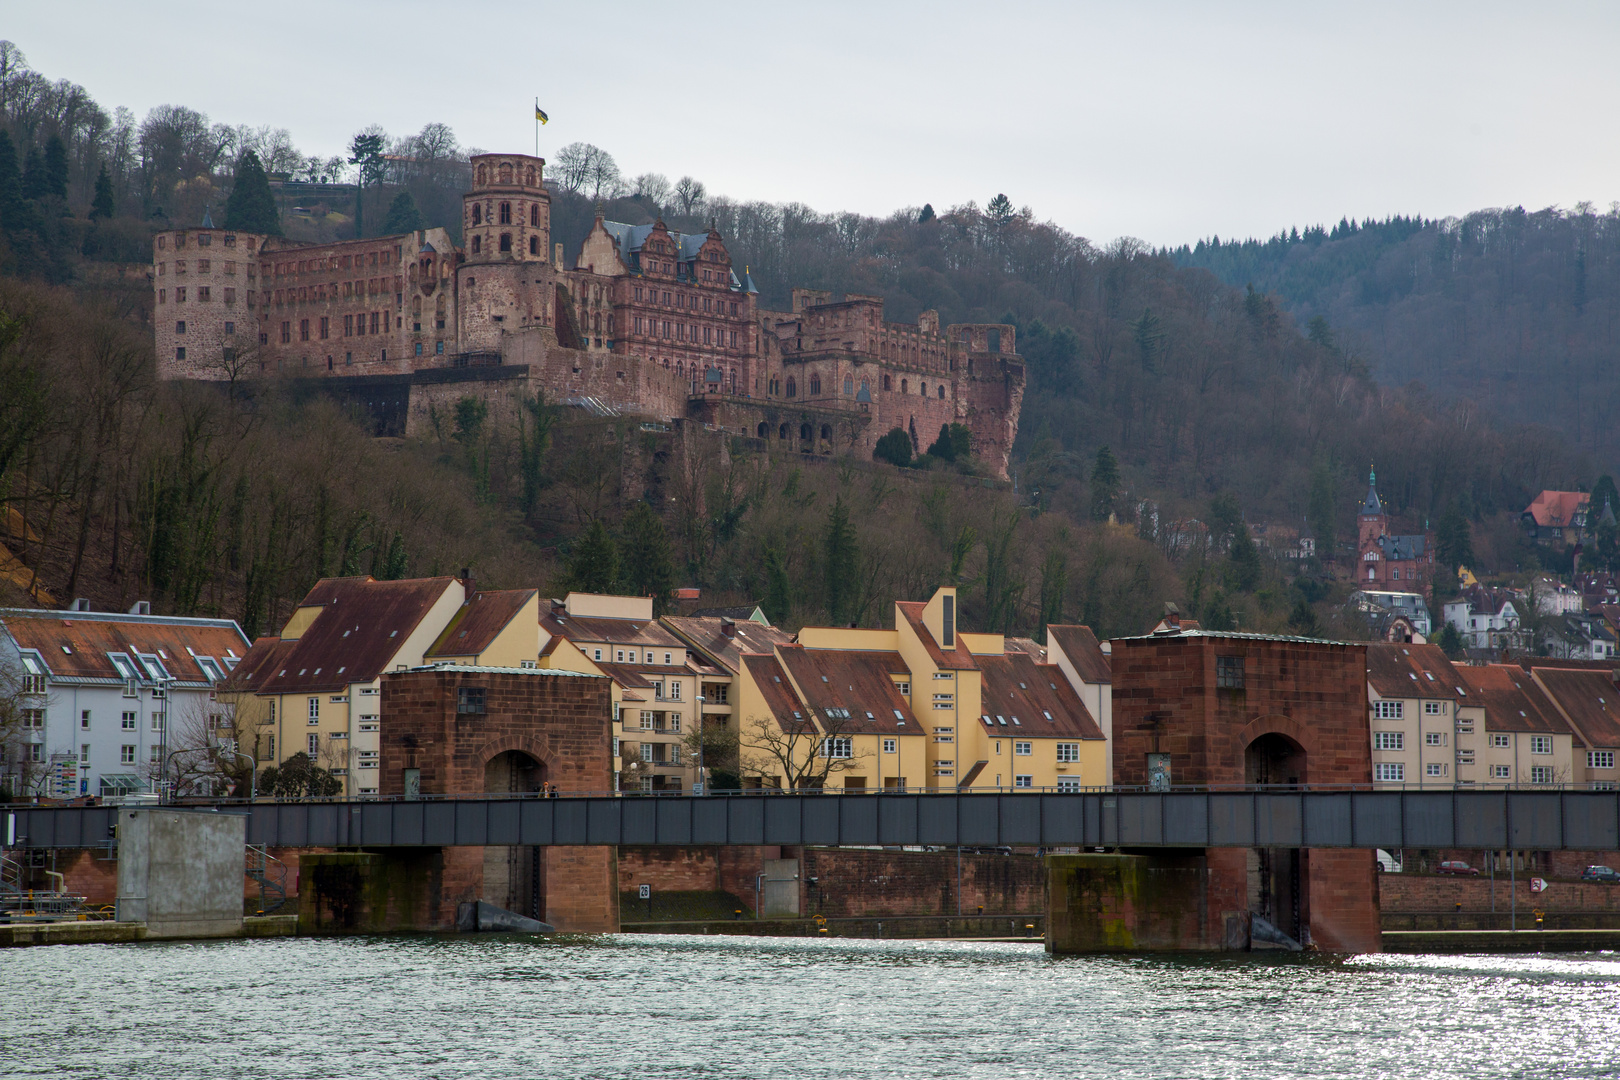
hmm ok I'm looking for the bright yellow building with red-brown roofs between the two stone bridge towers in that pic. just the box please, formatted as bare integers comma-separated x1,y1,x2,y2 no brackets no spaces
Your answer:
737,588,1110,790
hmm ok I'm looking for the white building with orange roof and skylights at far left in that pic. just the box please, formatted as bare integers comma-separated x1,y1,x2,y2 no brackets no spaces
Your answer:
0,601,248,798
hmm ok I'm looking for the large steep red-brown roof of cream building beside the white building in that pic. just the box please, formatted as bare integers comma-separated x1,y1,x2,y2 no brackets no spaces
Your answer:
259,575,455,693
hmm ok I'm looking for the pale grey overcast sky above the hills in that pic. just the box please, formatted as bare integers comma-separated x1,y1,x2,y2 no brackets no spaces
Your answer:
12,0,1620,244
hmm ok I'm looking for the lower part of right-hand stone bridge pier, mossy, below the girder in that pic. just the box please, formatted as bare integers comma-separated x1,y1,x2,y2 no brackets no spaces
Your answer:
1047,848,1380,955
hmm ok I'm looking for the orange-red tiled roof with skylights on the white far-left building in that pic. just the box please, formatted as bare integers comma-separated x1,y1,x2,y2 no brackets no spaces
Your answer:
0,609,249,685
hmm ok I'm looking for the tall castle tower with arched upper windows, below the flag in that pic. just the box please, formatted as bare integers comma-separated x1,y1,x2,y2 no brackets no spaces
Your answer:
457,154,556,351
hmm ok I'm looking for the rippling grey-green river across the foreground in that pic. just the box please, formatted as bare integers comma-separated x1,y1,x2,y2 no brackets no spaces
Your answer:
0,936,1620,1080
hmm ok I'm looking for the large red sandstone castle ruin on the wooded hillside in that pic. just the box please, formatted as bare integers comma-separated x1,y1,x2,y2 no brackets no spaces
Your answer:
152,154,1024,478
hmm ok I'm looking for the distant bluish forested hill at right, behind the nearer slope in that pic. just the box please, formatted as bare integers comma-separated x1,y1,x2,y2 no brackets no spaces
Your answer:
1168,204,1620,461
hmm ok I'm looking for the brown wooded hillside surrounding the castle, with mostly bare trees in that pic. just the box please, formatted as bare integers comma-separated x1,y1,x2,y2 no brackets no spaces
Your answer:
0,44,1594,650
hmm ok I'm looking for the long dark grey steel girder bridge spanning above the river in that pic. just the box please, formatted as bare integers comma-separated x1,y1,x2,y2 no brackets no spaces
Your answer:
0,789,1620,850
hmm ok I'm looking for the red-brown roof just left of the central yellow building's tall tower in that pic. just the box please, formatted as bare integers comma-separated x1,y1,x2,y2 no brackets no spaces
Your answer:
776,644,925,735
